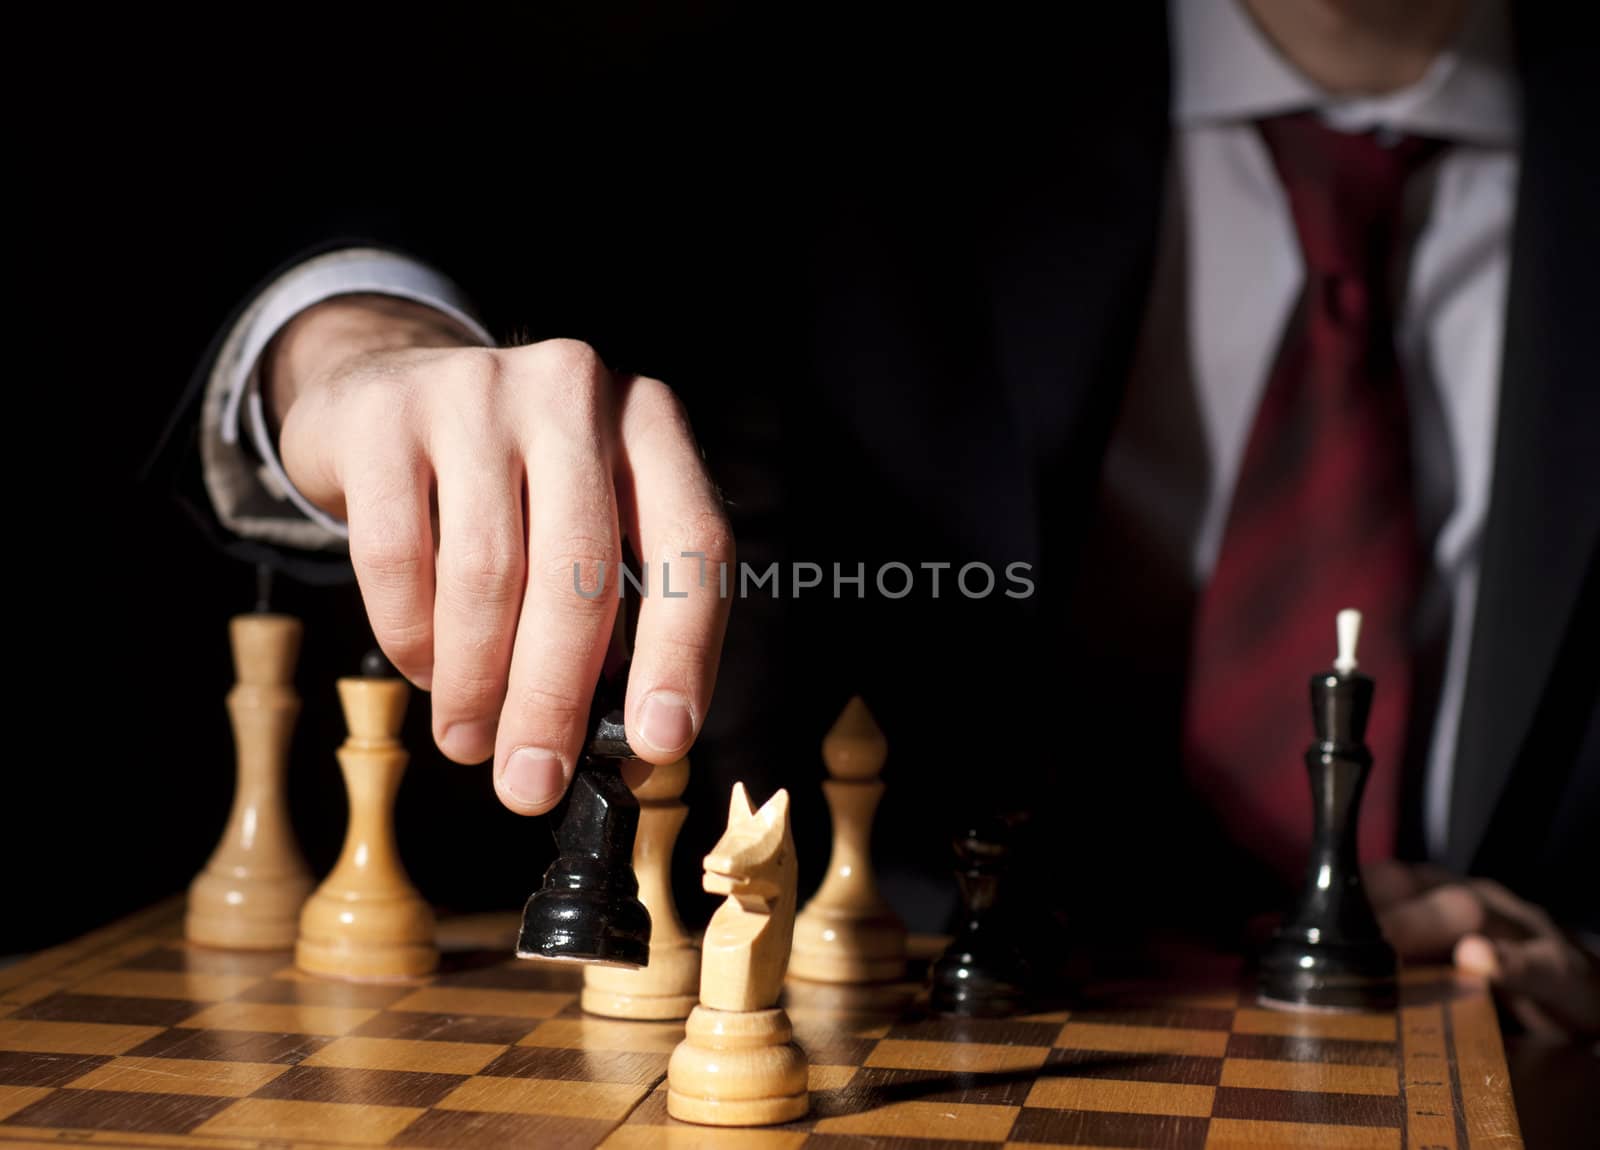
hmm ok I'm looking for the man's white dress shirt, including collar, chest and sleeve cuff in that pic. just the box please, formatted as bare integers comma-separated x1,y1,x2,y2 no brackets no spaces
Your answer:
205,0,1520,854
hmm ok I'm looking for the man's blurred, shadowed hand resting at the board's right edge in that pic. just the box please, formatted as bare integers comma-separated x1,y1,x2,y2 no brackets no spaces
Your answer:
1365,862,1600,1038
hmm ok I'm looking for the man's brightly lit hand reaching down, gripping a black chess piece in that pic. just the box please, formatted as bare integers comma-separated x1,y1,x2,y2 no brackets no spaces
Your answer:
264,296,733,814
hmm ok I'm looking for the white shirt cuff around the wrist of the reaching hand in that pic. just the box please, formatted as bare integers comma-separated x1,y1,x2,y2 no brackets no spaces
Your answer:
200,248,494,550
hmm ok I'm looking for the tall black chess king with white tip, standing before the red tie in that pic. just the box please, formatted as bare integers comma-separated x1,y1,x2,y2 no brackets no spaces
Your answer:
1256,611,1395,1011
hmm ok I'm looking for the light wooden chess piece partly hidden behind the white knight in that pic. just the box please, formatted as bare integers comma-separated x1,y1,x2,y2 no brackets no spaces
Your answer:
582,758,701,1022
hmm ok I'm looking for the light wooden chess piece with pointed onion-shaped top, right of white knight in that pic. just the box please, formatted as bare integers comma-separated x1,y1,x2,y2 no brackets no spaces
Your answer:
789,696,906,982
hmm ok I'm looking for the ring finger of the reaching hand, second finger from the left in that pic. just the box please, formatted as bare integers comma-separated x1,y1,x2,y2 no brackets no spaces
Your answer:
434,429,526,763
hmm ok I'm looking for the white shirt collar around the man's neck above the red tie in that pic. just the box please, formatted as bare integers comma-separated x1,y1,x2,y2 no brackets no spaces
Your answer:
1168,0,1522,147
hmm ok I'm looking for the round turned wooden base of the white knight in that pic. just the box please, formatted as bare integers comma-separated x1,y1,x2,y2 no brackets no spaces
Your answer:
667,1006,811,1126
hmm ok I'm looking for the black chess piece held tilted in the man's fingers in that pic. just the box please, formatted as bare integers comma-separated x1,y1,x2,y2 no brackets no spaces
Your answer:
517,675,650,966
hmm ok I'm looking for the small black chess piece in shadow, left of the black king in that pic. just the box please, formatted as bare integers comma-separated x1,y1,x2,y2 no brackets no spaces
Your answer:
928,819,1029,1017
